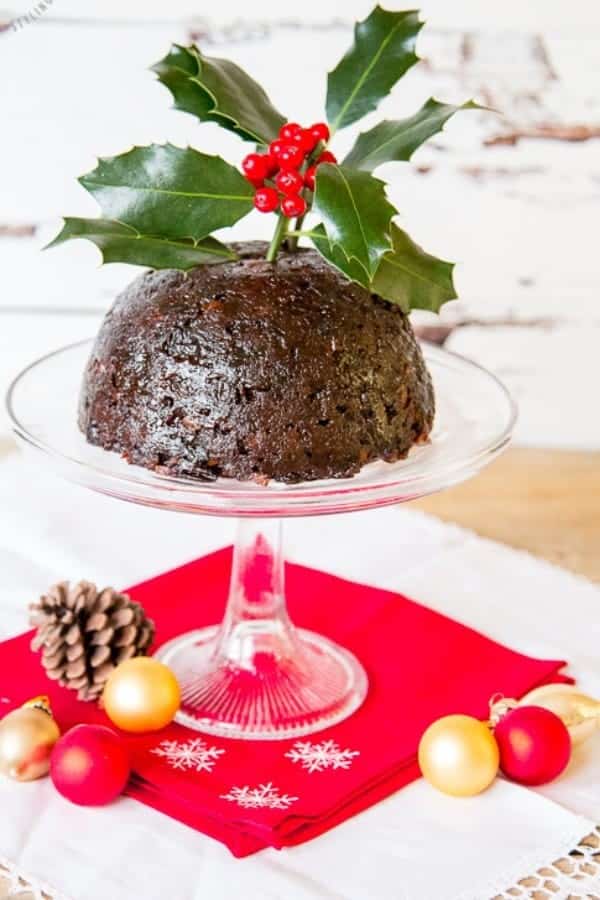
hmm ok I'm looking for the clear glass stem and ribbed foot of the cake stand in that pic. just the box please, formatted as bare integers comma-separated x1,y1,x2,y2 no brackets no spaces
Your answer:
156,519,368,740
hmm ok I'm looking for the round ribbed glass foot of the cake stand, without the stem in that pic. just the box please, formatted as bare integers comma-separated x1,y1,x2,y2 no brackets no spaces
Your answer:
158,627,367,740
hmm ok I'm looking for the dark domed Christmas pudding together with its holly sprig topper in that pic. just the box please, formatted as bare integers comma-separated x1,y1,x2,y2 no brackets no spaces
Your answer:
54,7,474,483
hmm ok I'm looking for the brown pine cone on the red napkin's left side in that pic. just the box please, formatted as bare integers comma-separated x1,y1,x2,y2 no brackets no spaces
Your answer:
30,581,154,700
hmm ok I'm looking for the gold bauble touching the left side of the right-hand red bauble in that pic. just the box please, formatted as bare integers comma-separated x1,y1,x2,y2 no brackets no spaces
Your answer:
419,715,499,797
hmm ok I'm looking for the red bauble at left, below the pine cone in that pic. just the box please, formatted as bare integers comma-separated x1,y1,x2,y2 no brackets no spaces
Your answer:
50,725,131,806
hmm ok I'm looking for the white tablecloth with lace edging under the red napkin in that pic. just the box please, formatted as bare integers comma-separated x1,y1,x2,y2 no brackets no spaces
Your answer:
0,451,600,900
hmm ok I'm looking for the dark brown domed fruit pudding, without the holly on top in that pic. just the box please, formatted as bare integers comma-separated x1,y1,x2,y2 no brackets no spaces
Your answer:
79,242,434,482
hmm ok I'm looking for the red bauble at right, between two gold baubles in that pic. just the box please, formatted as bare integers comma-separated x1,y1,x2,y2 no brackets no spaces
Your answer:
494,706,571,785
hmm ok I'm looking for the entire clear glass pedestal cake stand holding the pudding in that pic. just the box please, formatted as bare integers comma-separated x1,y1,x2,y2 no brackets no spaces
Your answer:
7,340,516,739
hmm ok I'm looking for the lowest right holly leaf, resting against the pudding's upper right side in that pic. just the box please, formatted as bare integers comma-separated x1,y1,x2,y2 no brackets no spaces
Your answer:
372,224,457,312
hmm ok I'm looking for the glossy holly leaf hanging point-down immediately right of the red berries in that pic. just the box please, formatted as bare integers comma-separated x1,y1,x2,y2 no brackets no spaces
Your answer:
313,163,396,281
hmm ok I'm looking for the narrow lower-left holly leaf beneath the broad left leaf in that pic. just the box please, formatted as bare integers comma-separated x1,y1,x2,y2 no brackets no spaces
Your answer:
48,218,237,269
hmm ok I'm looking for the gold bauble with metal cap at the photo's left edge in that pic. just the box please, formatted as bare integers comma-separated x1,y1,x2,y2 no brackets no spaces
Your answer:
0,697,60,781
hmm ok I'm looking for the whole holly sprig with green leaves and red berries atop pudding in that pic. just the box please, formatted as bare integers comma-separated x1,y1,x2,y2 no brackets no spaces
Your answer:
51,6,480,312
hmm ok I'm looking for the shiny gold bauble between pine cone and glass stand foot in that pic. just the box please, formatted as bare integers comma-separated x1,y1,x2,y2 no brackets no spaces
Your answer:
102,656,181,733
